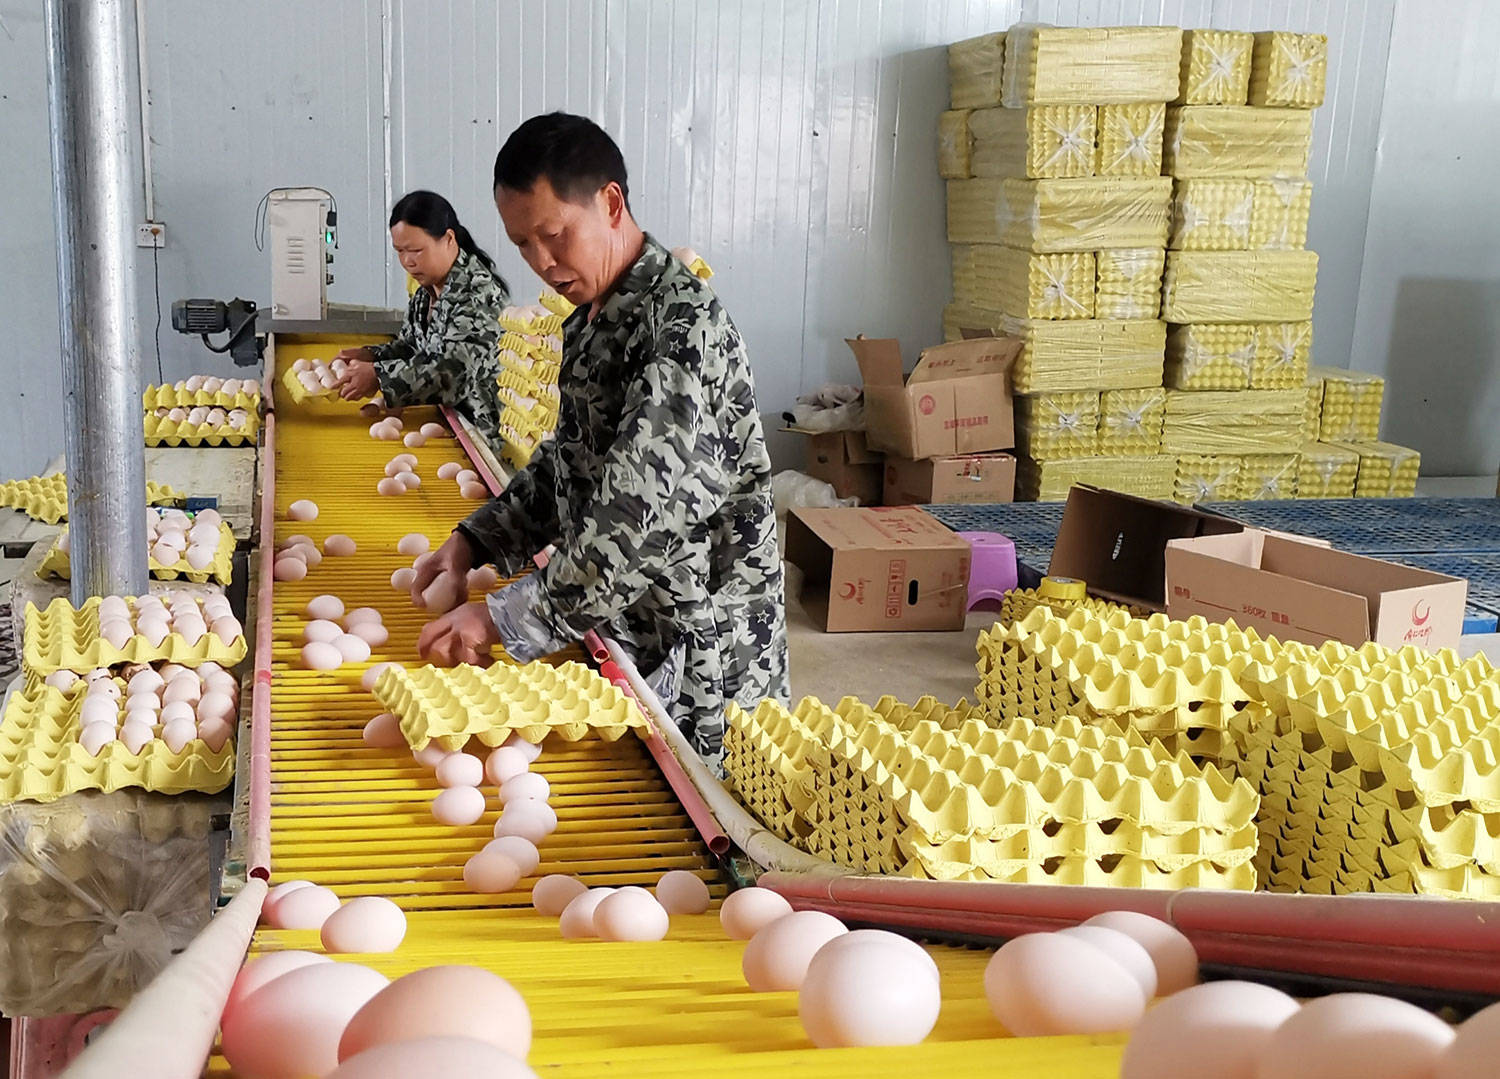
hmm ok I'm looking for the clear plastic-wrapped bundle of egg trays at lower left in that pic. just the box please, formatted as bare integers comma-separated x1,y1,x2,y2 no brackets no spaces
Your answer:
0,791,222,1016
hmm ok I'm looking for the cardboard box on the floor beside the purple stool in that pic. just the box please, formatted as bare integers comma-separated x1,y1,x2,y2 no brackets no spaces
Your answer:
786,506,971,633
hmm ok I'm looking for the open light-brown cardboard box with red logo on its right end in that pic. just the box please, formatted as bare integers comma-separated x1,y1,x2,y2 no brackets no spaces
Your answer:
1167,528,1469,650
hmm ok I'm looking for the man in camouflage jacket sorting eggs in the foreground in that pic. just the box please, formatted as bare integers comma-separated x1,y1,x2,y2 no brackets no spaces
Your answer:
413,113,788,764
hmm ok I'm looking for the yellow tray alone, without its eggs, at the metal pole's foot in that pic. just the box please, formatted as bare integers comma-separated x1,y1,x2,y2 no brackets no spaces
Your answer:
21,596,246,675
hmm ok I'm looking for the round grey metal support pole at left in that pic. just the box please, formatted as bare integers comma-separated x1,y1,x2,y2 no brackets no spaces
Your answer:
44,0,147,605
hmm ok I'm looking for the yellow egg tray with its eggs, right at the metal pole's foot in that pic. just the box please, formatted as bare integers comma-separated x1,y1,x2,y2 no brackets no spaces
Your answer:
21,591,248,675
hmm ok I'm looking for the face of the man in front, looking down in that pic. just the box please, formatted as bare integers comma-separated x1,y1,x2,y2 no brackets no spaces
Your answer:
495,177,626,308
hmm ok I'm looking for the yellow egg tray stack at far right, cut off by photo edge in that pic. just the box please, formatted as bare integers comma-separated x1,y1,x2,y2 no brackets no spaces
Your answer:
1235,645,1500,899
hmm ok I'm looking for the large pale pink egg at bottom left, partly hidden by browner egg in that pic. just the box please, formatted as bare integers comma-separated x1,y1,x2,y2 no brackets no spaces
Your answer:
221,963,390,1079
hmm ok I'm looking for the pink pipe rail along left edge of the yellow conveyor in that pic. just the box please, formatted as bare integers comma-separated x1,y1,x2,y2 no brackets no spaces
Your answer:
246,413,276,881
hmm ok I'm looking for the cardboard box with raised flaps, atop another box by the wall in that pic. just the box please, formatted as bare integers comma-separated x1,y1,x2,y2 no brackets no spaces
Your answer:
848,336,1022,461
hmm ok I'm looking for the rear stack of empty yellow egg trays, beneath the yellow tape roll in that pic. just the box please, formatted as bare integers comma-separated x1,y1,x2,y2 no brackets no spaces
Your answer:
977,606,1278,762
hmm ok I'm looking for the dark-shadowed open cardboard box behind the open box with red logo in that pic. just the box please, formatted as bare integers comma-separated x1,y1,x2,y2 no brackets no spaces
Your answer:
1047,485,1244,611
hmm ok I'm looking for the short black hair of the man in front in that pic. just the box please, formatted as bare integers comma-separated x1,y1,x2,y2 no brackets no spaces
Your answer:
495,113,630,207
